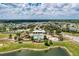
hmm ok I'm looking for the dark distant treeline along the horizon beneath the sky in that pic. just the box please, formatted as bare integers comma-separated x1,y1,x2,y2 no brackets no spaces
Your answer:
0,19,79,23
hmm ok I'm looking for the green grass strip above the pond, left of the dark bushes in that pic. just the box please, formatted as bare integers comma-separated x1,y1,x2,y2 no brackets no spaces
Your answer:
0,42,47,52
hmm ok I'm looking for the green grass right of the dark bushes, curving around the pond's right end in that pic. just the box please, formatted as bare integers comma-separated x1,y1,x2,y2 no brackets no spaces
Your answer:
53,41,79,56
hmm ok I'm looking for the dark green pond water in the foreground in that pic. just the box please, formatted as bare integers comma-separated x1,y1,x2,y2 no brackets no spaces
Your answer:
0,48,69,56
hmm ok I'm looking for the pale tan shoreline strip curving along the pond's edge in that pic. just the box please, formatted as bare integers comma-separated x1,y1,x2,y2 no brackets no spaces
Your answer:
0,46,73,56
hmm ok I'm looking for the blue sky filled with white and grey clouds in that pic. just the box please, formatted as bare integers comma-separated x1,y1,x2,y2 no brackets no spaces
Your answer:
0,3,79,19
